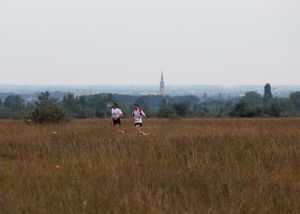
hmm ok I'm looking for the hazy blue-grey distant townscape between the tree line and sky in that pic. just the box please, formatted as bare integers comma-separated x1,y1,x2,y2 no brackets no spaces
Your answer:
0,84,300,102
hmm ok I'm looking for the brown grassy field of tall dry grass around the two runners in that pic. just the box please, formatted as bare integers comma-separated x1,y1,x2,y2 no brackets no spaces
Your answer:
0,119,300,213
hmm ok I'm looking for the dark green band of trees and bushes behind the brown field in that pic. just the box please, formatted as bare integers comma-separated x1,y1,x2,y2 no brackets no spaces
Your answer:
0,84,300,123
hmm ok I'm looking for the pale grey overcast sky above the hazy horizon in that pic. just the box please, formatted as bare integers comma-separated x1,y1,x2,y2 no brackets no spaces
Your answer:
0,0,300,85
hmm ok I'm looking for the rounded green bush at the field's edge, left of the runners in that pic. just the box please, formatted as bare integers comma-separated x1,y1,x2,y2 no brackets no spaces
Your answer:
29,91,66,123
